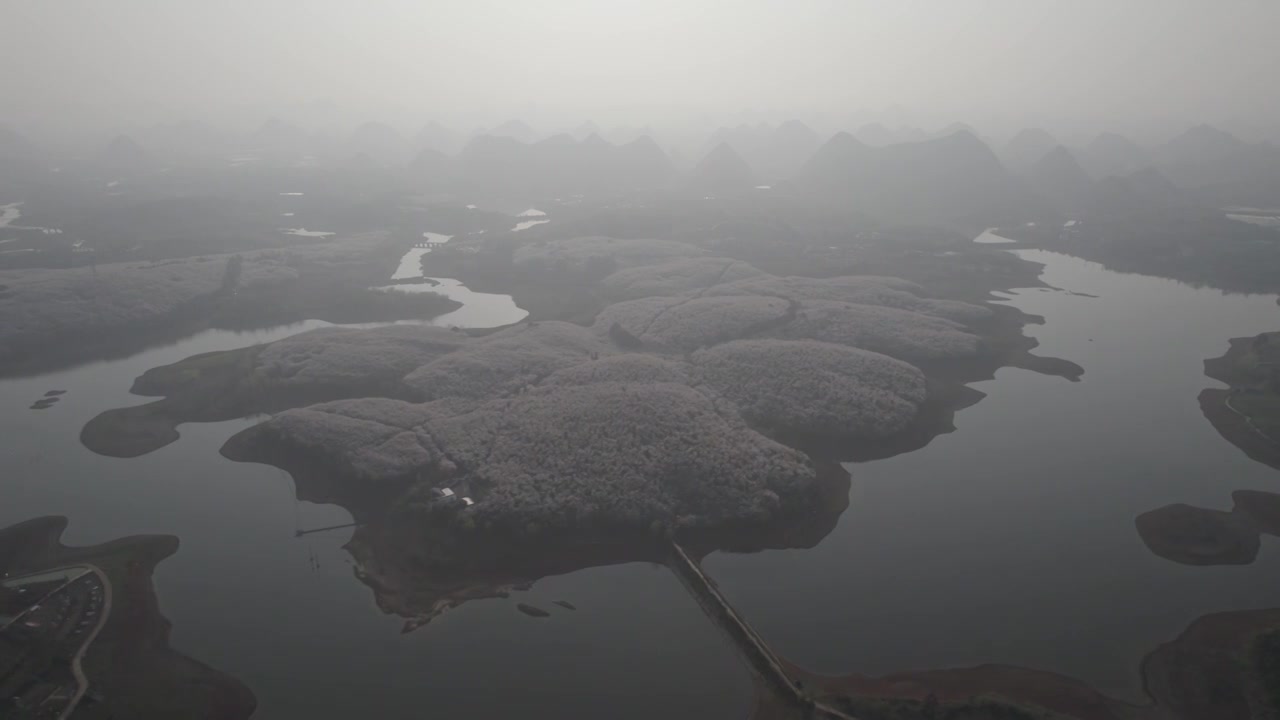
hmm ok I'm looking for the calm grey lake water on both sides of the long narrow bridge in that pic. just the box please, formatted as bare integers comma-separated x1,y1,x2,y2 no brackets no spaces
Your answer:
0,242,1280,719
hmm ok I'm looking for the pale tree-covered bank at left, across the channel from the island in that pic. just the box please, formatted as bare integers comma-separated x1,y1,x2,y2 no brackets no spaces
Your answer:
0,233,461,375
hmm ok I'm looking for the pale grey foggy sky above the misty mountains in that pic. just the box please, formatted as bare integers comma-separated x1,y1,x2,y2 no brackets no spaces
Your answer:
0,0,1280,140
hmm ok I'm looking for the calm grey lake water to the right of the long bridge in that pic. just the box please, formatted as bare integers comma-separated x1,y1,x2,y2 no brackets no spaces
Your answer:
704,251,1280,700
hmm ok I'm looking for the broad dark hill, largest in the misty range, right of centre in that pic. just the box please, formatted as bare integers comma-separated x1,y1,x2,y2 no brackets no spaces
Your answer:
796,131,1036,228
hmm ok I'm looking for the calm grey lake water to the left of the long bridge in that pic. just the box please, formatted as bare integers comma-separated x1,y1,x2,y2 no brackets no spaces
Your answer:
0,270,753,720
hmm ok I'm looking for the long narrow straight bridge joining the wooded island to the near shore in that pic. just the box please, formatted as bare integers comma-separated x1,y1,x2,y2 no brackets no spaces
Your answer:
671,541,856,720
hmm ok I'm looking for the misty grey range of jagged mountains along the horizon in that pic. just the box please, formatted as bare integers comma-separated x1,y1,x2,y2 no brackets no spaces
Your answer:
0,119,1280,225
